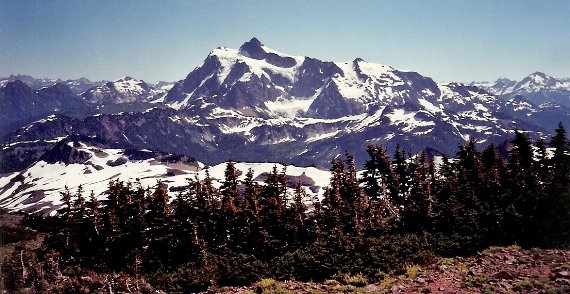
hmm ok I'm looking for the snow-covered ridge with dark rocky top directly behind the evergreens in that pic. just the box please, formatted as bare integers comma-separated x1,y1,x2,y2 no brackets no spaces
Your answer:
0,140,330,214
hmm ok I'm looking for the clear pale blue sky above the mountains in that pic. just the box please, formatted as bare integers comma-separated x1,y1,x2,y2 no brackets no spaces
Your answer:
0,0,570,82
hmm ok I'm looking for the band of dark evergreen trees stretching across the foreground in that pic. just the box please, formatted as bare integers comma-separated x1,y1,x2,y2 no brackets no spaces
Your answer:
4,124,570,292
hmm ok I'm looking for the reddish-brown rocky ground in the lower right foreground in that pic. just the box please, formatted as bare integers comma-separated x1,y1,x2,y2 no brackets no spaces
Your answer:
208,246,570,294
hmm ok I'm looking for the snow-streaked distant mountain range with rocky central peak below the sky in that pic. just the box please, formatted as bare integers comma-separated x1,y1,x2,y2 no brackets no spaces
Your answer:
0,38,570,172
